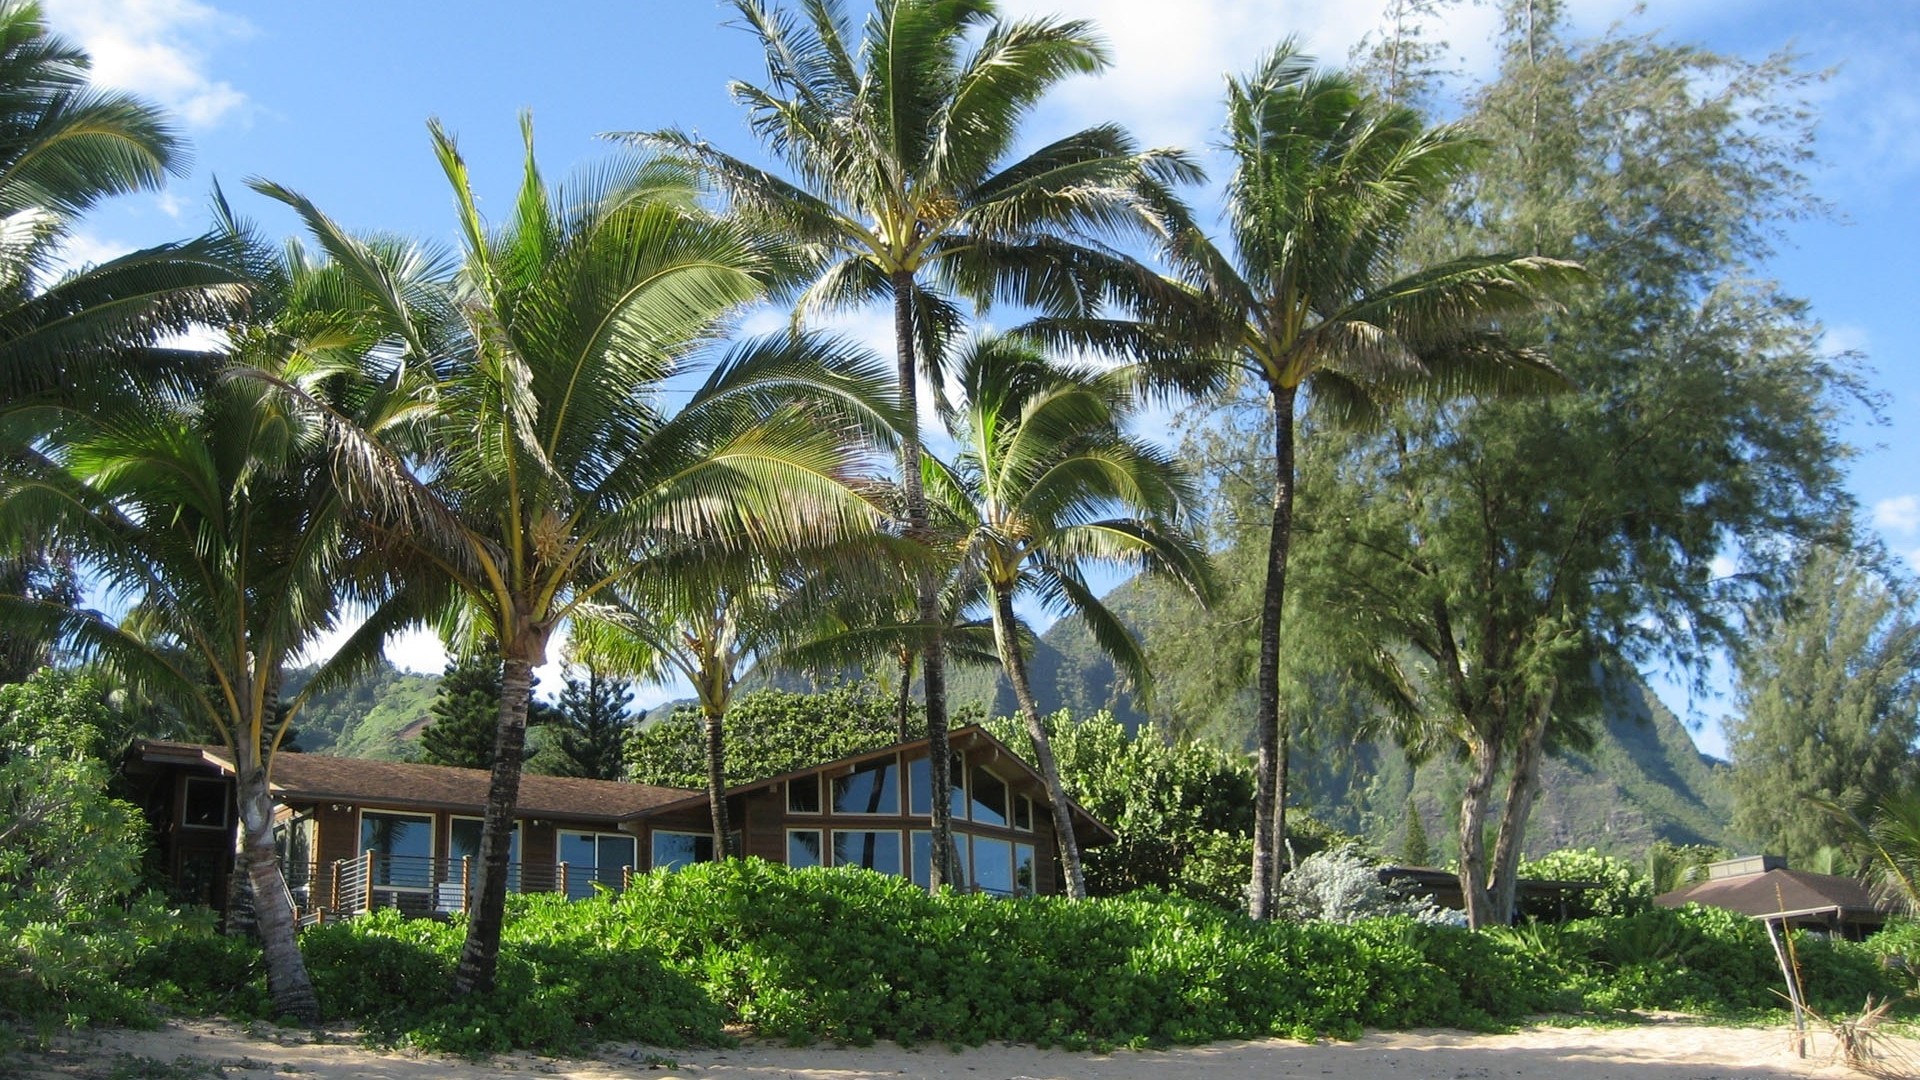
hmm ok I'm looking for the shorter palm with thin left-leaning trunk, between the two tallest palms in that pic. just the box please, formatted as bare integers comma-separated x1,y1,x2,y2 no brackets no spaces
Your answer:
927,336,1210,899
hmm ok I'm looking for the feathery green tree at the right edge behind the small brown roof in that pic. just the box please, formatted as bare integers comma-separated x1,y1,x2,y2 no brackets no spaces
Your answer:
1726,550,1920,867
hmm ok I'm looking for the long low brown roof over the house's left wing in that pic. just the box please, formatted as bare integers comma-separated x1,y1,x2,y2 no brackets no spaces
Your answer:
134,740,695,822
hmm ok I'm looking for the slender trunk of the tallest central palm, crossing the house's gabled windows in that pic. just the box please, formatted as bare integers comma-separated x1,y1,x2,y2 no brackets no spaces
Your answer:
893,269,964,890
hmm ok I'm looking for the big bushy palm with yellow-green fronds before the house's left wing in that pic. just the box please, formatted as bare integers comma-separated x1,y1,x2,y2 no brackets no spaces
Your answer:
263,121,895,994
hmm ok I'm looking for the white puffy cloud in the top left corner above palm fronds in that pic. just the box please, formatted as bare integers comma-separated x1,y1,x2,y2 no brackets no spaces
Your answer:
46,0,253,127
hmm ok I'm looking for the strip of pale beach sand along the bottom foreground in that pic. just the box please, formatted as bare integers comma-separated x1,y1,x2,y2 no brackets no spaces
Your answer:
0,1019,1920,1080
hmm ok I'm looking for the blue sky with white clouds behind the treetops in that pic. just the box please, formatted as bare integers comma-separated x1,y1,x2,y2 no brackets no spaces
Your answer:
33,0,1920,751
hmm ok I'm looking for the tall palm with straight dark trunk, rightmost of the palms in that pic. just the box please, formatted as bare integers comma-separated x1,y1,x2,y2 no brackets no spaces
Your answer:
1035,40,1578,919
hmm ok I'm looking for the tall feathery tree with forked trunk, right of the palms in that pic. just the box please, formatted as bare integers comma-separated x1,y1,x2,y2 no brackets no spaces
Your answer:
1302,0,1855,926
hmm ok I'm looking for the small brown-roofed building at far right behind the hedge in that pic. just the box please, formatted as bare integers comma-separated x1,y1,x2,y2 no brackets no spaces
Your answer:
1653,855,1897,940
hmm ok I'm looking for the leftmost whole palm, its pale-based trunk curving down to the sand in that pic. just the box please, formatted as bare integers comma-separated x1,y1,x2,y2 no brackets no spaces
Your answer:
0,204,426,1022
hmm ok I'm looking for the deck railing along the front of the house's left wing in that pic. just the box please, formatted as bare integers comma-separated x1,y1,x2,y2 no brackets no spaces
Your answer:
288,851,634,924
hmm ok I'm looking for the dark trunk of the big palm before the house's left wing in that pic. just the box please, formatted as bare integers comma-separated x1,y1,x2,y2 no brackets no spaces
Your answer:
453,630,545,995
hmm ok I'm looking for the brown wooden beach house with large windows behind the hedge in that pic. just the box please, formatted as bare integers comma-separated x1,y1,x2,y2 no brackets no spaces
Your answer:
127,726,1114,920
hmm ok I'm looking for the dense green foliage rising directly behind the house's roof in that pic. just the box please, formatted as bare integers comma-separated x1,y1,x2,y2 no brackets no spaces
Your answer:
626,682,899,788
